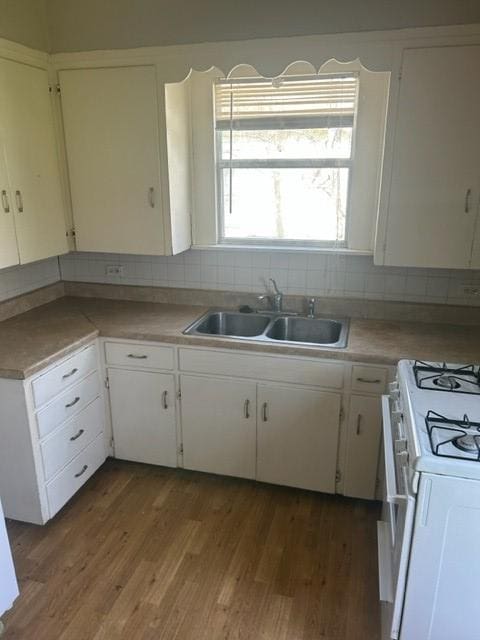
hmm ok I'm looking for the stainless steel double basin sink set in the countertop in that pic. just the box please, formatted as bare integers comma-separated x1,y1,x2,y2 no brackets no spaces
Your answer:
183,310,348,349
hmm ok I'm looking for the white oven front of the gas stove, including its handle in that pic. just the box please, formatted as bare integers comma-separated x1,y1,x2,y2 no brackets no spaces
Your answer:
378,396,415,640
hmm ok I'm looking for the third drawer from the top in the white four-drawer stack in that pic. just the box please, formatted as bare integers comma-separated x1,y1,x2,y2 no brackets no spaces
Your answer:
40,398,103,480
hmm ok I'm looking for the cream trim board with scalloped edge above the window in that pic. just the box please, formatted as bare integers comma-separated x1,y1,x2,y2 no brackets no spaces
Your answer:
50,24,480,82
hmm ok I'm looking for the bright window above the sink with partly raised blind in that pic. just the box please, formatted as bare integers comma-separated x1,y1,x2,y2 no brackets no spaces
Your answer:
215,73,358,246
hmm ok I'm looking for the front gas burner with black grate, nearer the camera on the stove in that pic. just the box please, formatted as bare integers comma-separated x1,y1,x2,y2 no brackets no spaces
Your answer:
425,411,480,461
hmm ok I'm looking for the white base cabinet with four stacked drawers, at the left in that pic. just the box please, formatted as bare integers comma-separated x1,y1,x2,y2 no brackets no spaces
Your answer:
0,343,106,524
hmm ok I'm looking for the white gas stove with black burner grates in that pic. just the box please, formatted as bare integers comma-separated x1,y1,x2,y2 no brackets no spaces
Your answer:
378,360,480,640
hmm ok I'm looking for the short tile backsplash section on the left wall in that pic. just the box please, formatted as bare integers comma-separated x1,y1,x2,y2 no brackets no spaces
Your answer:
0,258,60,302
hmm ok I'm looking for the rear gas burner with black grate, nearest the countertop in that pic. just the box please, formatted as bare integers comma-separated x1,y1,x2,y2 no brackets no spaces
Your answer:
413,360,480,395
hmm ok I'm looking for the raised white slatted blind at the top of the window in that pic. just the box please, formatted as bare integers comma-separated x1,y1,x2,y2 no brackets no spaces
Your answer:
215,74,358,129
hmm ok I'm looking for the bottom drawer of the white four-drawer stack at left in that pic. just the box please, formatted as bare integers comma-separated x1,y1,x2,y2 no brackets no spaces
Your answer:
47,433,106,518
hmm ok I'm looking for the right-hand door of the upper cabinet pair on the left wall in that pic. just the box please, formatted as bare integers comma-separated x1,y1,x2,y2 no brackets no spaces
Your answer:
0,59,68,264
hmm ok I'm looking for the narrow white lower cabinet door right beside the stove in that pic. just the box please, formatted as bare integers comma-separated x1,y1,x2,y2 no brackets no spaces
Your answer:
344,395,382,500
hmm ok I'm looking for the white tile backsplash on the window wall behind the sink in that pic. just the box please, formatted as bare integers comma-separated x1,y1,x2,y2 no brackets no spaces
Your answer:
58,249,480,305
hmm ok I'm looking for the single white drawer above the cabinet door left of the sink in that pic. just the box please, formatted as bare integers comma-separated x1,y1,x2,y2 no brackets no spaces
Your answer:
105,342,174,369
